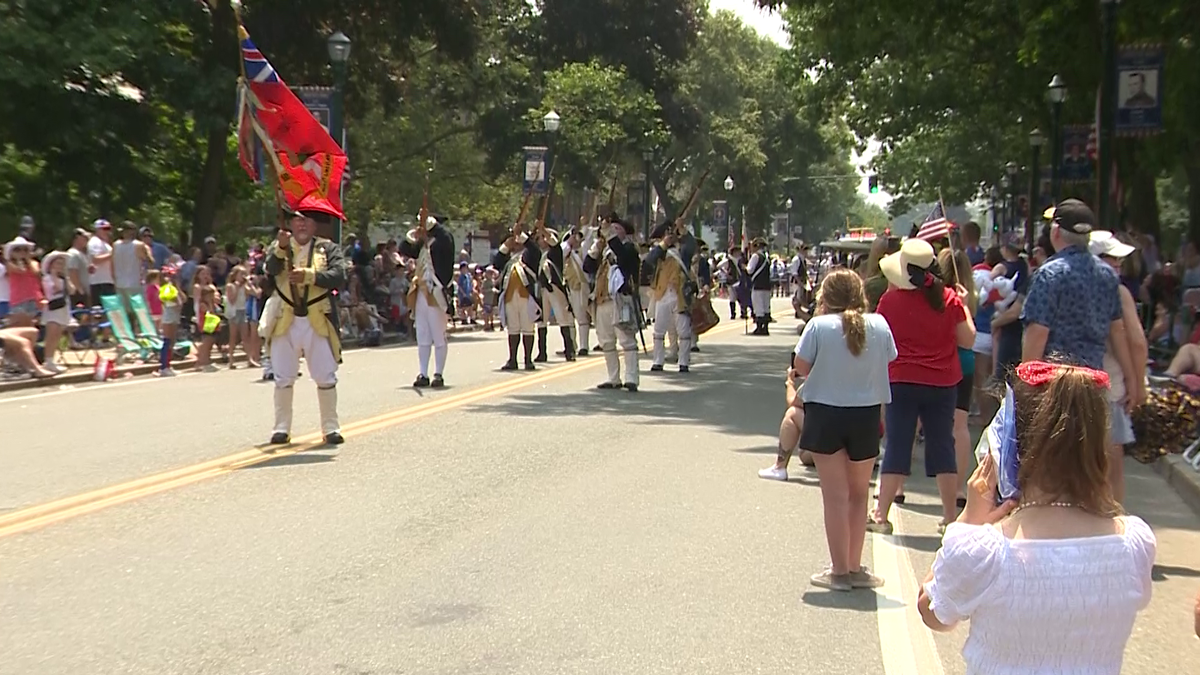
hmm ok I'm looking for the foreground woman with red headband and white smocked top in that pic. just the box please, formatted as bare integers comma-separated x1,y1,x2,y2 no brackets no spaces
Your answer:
917,362,1156,675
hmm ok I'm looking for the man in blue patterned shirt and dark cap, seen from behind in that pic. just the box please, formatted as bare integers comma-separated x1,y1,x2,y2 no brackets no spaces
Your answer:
1021,199,1141,393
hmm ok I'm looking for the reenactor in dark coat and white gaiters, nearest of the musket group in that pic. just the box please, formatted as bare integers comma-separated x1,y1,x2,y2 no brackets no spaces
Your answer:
583,210,641,392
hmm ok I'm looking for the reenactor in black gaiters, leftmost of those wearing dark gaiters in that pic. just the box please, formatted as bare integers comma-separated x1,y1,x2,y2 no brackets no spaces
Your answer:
492,223,541,370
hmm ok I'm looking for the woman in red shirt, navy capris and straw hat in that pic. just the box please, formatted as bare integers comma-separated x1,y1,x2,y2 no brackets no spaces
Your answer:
871,239,974,534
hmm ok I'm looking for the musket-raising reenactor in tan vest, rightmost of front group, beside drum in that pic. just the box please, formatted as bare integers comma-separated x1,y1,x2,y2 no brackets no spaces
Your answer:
646,222,697,372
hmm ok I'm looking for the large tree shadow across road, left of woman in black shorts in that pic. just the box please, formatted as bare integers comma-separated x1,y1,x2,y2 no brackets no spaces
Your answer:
473,342,790,439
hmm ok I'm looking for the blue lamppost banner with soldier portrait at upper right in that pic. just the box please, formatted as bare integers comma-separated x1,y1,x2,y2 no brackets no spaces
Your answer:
1116,44,1166,136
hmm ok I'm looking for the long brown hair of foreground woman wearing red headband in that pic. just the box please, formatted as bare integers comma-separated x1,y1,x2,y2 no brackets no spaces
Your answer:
1013,366,1122,515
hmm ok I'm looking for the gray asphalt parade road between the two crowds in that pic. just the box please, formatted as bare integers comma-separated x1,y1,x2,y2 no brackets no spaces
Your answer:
0,301,1200,675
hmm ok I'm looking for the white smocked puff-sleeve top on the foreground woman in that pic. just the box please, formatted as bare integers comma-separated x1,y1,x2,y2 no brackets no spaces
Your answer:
925,515,1156,675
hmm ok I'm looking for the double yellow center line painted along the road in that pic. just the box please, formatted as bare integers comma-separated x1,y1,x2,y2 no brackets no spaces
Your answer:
0,299,787,538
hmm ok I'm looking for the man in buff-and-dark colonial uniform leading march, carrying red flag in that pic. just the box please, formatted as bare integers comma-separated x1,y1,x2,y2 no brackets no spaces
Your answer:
262,195,347,446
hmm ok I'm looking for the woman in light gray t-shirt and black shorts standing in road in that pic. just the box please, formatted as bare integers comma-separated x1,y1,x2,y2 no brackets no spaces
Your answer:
793,269,896,591
